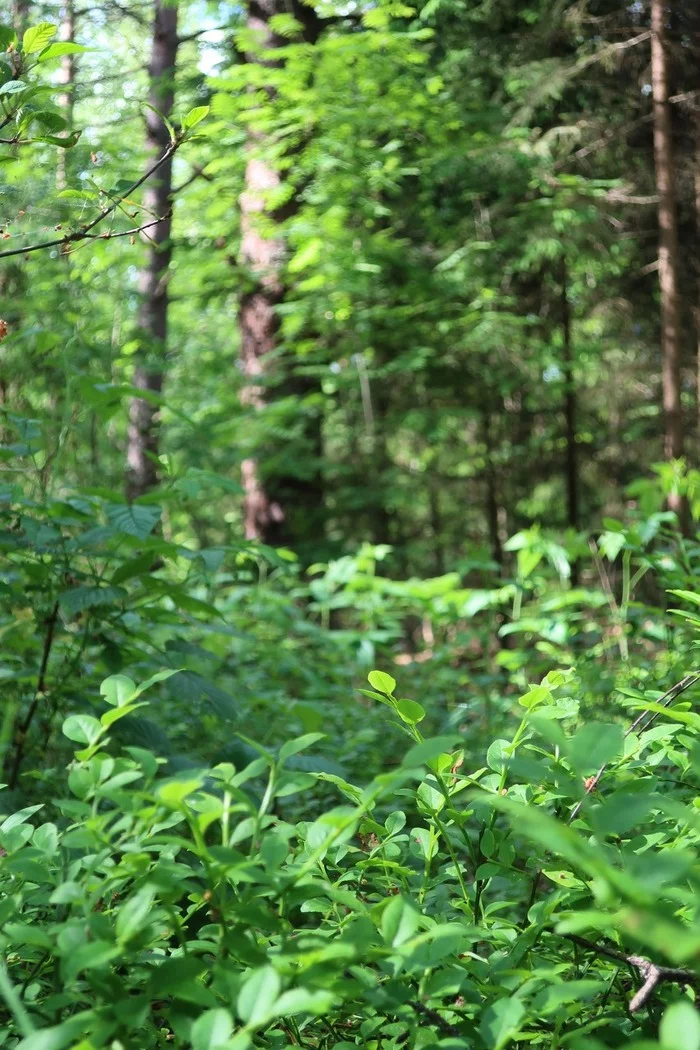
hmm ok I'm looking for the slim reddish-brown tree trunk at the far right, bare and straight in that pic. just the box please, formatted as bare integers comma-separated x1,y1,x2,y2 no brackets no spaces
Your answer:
651,0,683,513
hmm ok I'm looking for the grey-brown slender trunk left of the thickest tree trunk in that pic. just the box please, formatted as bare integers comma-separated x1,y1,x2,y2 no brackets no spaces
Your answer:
127,0,178,500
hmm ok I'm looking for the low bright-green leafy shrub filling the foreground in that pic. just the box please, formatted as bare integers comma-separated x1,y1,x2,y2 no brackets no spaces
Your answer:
0,672,700,1050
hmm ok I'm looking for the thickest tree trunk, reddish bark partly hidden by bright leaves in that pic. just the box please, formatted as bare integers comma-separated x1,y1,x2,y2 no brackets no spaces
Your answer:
238,0,323,547
